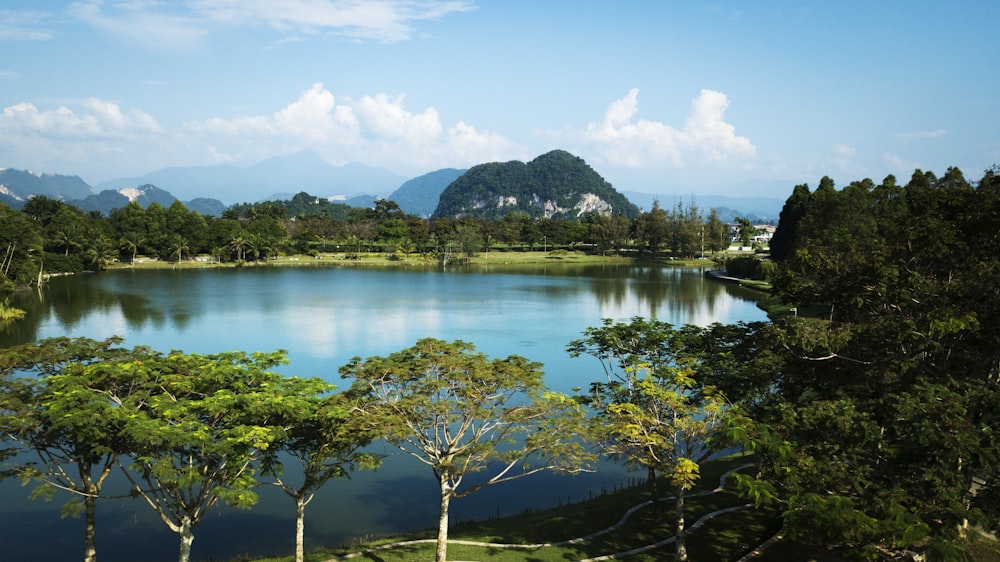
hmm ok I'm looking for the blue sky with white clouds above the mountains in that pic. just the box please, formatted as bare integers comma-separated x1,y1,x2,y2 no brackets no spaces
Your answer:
0,0,1000,198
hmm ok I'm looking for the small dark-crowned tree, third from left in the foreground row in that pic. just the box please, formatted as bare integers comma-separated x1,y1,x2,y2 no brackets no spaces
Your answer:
262,378,380,562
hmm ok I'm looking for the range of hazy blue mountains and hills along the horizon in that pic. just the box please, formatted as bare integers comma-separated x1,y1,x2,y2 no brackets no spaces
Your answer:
0,151,784,222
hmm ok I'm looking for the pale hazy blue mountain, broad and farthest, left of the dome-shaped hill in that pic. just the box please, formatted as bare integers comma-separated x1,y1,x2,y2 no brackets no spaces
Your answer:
97,150,406,205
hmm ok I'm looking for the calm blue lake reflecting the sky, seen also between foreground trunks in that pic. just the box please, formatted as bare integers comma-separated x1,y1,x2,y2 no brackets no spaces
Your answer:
0,265,766,562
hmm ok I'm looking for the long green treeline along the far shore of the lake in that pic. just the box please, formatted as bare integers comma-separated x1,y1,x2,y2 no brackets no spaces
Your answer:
0,193,729,286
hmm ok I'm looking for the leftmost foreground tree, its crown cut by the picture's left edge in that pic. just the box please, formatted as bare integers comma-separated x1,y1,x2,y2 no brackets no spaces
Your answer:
0,338,148,562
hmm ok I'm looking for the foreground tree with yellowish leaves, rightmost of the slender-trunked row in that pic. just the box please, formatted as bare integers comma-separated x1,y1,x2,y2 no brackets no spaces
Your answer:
568,317,729,560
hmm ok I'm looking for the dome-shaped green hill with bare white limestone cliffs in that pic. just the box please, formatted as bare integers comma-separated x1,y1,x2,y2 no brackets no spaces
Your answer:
432,150,639,219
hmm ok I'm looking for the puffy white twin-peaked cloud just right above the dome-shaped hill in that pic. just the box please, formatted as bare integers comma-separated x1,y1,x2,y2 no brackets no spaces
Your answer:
567,88,756,168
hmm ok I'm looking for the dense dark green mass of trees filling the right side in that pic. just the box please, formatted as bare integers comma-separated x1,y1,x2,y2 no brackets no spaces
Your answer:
752,164,1000,558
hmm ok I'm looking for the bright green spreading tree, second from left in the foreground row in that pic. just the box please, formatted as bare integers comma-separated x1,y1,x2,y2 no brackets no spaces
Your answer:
118,351,299,562
